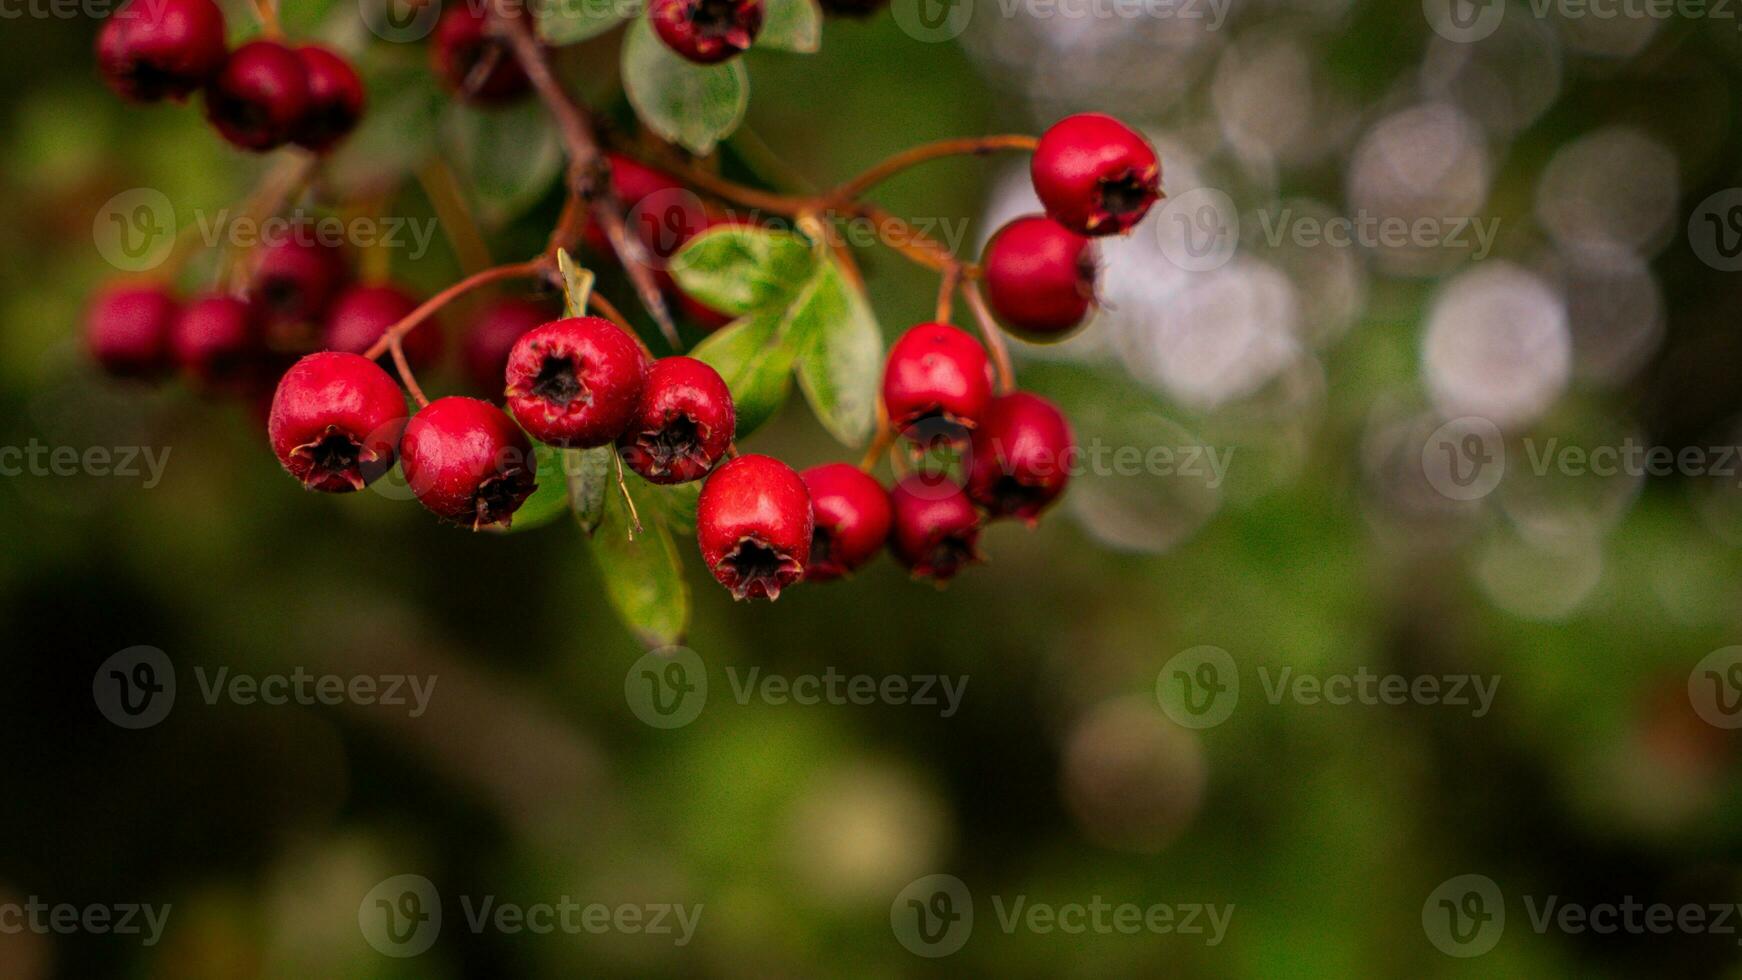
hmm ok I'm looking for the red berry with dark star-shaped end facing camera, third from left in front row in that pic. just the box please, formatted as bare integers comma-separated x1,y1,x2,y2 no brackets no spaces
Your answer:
505,317,648,449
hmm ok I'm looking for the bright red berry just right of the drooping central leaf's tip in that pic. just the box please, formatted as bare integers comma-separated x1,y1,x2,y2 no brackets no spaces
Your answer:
883,324,991,442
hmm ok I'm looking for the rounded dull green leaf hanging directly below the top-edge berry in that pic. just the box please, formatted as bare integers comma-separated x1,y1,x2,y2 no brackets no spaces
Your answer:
624,17,751,155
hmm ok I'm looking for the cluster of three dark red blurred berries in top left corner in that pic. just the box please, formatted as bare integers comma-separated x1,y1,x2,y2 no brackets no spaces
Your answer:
98,0,364,153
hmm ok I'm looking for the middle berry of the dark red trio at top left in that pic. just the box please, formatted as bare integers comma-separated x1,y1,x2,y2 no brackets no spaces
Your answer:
206,40,312,153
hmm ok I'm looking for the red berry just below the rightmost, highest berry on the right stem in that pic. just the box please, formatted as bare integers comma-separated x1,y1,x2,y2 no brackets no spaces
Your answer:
982,214,1096,341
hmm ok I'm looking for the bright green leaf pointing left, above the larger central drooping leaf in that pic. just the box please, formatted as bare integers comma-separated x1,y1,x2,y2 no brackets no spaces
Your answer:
669,225,817,317
